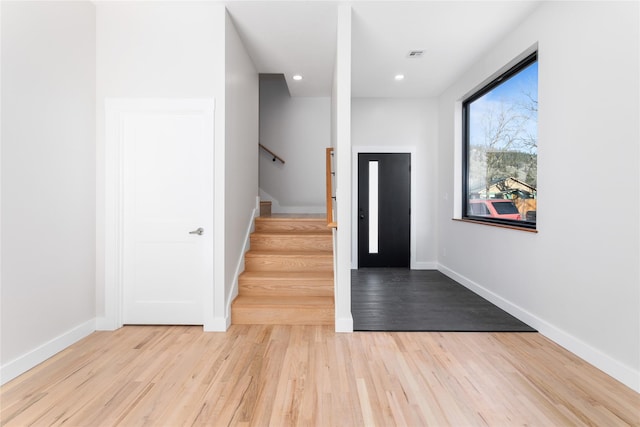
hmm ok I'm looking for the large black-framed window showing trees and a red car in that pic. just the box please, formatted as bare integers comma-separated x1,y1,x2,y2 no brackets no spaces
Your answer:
462,53,538,229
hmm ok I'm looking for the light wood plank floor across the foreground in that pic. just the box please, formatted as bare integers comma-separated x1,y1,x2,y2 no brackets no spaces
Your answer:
0,325,640,426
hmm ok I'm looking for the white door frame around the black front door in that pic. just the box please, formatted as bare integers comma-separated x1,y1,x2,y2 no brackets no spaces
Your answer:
351,145,417,270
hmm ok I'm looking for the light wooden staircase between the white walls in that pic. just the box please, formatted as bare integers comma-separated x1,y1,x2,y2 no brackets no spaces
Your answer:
231,215,334,325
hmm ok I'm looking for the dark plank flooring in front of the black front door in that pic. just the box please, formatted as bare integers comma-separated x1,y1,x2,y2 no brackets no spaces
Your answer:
351,268,535,332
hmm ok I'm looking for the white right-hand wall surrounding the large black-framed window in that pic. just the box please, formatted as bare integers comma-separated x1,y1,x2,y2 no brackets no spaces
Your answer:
437,2,640,390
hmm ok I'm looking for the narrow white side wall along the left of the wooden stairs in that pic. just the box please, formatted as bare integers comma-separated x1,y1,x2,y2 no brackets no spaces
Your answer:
224,14,259,328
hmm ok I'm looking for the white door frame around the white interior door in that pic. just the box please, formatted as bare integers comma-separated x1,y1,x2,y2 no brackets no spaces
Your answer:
98,98,215,330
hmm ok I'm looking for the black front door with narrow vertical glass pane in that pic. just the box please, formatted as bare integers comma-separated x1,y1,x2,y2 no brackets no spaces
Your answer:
358,153,411,268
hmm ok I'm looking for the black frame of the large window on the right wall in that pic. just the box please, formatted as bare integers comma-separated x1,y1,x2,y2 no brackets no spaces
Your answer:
462,50,538,230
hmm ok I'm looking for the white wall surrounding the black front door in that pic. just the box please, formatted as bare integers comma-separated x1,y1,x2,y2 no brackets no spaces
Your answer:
351,98,438,269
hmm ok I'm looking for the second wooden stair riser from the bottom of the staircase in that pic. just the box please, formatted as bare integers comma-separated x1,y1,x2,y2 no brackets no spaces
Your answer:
238,277,333,297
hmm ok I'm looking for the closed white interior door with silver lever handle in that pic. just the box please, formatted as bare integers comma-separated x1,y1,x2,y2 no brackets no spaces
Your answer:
119,100,213,324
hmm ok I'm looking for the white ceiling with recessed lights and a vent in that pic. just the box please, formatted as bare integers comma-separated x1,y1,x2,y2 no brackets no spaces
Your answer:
227,0,540,97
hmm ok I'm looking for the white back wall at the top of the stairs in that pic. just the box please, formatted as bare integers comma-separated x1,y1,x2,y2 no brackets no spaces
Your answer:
260,78,331,213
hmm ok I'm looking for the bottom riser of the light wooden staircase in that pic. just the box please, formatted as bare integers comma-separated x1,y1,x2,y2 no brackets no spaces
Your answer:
231,307,334,325
